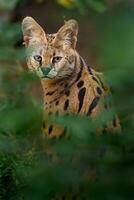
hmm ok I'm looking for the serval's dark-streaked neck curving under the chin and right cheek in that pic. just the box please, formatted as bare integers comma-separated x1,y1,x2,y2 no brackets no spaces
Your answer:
41,53,85,101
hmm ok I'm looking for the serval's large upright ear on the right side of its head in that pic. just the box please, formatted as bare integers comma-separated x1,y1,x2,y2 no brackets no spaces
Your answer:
54,19,78,49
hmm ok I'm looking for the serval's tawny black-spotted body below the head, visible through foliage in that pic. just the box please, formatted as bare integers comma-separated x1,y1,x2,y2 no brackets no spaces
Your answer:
42,62,119,137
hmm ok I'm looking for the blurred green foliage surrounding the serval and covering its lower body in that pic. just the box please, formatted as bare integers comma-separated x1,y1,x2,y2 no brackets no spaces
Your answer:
0,0,134,200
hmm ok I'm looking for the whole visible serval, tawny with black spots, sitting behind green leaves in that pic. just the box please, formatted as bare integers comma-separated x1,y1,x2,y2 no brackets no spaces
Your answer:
22,17,120,137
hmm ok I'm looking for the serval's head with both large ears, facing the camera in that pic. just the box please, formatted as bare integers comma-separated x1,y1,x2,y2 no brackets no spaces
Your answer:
22,17,78,80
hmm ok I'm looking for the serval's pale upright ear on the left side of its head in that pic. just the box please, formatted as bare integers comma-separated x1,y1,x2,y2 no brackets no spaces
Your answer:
22,17,47,46
